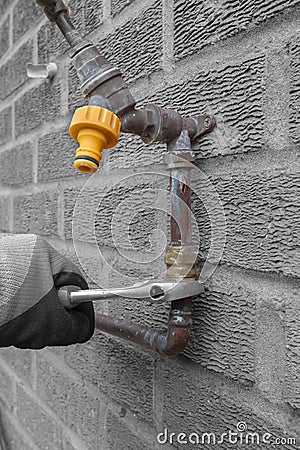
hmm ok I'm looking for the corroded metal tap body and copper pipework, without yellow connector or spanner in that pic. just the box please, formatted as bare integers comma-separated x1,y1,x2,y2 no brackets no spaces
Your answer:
36,0,215,356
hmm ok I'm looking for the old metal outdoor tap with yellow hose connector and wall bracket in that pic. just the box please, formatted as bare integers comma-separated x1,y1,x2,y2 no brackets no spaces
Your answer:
36,0,214,172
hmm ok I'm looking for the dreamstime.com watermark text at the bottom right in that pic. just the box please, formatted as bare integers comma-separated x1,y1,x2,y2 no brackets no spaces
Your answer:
157,422,296,448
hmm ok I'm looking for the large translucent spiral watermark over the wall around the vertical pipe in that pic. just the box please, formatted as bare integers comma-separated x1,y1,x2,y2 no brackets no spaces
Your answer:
72,161,226,289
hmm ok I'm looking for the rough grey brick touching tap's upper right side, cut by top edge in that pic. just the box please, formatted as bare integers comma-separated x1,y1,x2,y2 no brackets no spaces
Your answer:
99,0,163,82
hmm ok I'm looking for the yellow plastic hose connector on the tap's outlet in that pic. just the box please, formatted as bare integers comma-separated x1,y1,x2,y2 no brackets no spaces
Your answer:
69,106,121,172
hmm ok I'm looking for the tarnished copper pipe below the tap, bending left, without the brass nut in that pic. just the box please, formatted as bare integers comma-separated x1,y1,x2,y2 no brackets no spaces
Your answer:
95,131,196,356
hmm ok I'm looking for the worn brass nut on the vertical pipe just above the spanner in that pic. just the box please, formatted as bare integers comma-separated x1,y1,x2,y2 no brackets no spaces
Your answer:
165,245,198,280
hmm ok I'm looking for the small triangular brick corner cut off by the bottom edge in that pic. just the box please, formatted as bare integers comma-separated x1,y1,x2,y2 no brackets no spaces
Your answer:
106,413,153,450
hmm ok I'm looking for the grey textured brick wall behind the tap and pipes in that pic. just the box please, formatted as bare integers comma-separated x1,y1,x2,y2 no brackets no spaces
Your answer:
0,0,300,450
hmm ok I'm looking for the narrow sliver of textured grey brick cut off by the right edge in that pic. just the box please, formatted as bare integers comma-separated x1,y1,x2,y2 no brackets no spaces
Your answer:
289,35,300,145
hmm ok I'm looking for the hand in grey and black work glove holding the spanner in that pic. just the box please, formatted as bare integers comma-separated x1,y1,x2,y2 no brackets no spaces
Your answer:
0,234,95,349
